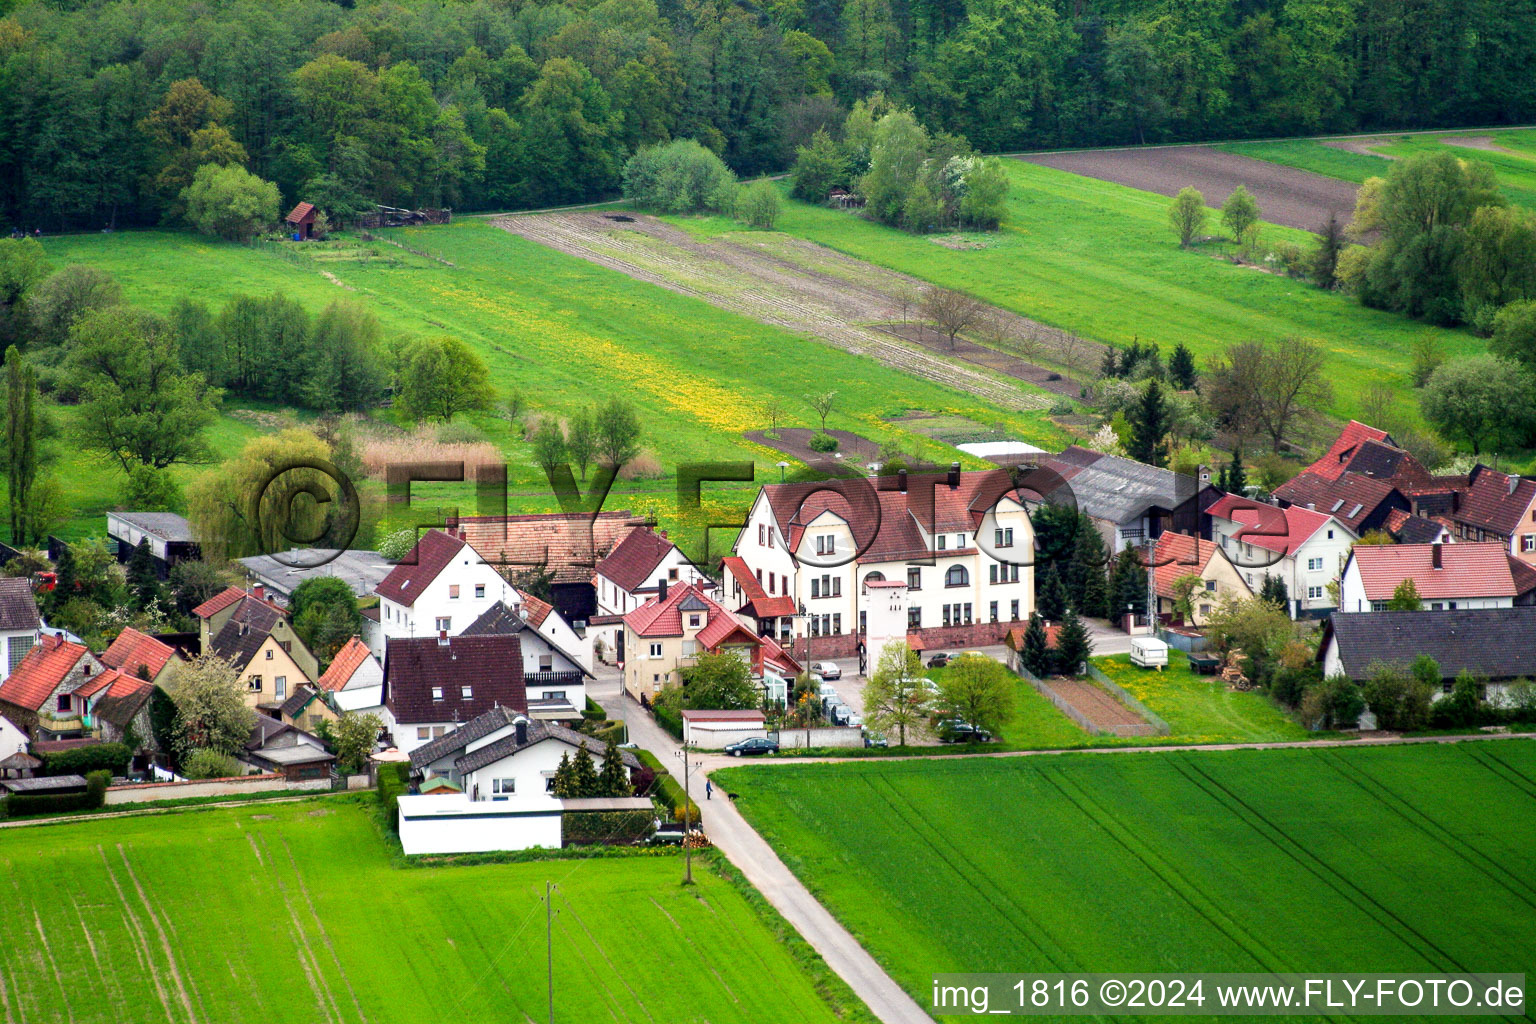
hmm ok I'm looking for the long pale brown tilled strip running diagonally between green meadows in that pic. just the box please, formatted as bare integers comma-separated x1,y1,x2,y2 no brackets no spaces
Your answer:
495,212,1100,410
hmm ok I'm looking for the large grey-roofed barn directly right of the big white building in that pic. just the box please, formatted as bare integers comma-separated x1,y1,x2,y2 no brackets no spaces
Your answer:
1038,445,1221,554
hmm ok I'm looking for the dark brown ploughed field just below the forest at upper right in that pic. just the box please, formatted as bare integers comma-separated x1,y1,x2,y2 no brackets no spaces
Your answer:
1020,146,1355,230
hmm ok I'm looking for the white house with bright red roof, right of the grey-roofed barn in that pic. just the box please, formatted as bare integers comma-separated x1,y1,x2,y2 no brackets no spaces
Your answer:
1209,494,1358,619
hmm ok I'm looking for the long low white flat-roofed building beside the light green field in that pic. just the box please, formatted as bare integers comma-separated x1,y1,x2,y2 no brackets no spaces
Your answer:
399,794,561,855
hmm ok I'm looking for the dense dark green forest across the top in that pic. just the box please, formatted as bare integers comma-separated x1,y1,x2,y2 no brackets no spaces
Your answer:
0,0,1536,230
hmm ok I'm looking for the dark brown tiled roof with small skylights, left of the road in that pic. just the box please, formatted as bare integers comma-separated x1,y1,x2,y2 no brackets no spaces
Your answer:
384,634,528,723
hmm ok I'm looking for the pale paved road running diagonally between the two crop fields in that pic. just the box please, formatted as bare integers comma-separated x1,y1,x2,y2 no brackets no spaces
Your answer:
588,668,932,1024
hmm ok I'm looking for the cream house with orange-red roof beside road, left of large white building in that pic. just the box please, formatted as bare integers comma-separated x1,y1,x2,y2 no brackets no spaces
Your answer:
624,580,800,700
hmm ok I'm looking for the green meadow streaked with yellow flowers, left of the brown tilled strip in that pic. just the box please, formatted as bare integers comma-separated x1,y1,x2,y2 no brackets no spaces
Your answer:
45,220,1064,554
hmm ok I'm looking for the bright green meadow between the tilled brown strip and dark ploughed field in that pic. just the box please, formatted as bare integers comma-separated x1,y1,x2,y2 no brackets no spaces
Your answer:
674,161,1484,418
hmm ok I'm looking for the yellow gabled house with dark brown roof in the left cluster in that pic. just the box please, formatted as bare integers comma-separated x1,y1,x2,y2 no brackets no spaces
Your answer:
194,586,319,712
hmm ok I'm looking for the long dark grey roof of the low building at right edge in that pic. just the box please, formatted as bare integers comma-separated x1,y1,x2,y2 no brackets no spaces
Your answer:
1318,606,1536,679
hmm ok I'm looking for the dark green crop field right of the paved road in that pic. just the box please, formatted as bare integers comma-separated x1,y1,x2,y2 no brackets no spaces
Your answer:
713,740,1536,1006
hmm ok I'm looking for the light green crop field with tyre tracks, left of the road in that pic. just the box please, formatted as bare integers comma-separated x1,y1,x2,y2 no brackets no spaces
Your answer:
0,800,869,1024
